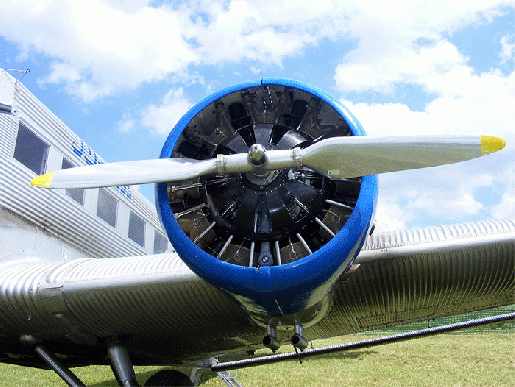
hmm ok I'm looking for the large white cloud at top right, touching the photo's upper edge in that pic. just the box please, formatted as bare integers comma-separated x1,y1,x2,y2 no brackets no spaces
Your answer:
335,0,505,93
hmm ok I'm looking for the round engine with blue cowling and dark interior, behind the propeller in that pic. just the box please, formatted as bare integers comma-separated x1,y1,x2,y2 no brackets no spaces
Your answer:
156,79,377,325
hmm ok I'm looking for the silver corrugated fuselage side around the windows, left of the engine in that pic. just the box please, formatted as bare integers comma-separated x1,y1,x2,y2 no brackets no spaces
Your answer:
0,70,169,263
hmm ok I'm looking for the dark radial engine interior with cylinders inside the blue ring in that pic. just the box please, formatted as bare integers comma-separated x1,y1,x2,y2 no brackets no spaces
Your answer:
168,86,361,267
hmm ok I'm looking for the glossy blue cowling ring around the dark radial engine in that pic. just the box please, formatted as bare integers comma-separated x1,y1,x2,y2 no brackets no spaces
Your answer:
156,79,377,325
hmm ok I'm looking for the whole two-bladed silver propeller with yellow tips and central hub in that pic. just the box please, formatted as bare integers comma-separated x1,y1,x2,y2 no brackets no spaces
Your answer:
31,135,506,188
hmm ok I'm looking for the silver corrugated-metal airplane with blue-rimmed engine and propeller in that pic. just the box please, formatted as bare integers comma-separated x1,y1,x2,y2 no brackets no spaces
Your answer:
0,70,515,386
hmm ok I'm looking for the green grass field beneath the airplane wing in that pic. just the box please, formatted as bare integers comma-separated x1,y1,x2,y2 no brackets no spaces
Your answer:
0,333,515,387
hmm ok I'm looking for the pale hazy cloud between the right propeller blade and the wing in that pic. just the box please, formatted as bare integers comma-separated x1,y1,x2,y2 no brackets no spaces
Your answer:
370,159,499,231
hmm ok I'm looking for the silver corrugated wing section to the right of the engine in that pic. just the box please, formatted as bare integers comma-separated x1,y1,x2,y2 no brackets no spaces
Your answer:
309,219,515,337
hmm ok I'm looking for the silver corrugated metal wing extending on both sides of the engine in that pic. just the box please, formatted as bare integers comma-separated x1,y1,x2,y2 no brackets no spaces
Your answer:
0,220,515,366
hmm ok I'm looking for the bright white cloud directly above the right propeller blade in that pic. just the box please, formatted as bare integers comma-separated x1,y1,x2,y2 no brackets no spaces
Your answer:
342,70,515,141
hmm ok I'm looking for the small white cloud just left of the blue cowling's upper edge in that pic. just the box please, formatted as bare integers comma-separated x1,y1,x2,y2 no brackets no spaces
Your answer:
141,88,192,135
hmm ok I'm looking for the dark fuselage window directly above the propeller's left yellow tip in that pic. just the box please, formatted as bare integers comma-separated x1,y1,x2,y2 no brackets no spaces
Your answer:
14,122,49,175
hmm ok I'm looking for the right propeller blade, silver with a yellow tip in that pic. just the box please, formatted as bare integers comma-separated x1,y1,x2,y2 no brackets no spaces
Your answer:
302,135,506,179
